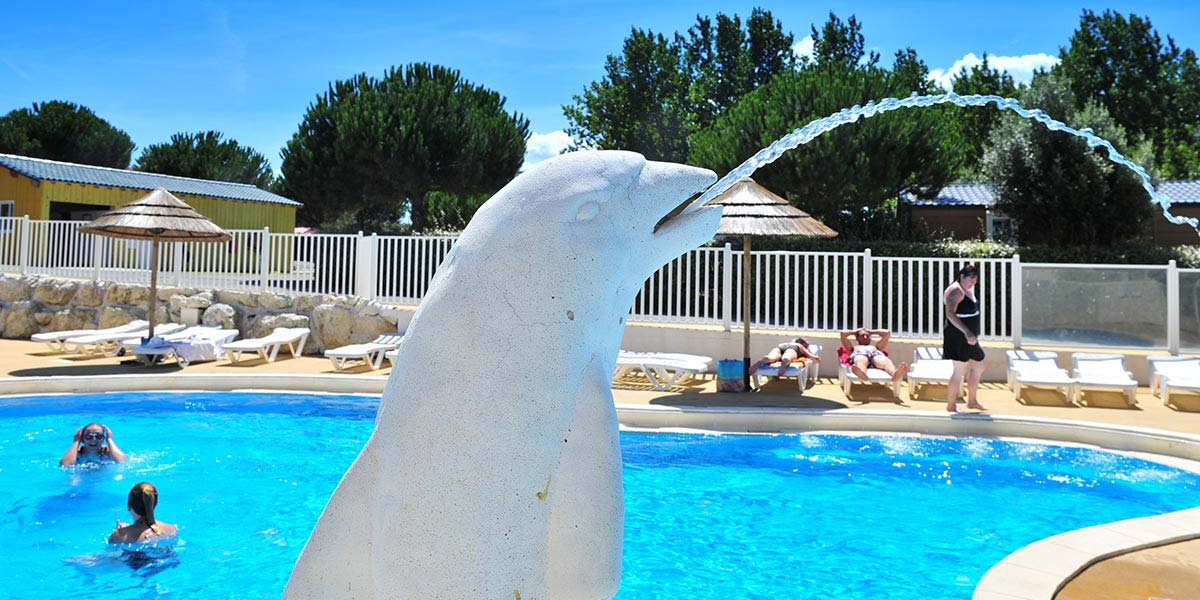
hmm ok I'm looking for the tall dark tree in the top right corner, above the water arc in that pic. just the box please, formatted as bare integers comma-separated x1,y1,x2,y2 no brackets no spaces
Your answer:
1055,10,1200,178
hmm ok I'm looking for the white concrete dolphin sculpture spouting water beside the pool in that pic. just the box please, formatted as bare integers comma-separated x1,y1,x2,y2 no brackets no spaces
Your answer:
284,151,720,600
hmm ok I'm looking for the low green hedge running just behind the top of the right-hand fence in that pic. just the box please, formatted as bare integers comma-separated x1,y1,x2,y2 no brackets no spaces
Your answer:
714,238,1200,269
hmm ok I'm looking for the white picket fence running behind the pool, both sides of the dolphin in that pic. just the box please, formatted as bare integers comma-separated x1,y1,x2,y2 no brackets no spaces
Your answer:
0,217,1200,352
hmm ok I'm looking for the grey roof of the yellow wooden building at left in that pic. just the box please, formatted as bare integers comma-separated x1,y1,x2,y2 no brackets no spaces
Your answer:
0,154,300,206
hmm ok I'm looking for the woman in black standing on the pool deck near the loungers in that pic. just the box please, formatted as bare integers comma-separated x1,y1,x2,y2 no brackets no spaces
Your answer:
942,263,986,413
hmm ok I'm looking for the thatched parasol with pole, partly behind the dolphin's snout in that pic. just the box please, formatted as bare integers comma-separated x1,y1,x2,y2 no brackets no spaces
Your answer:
708,178,838,390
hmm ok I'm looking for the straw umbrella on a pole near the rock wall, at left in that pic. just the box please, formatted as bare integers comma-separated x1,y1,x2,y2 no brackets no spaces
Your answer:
79,187,233,337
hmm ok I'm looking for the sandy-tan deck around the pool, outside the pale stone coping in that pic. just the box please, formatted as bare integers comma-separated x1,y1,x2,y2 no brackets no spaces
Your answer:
0,340,1200,600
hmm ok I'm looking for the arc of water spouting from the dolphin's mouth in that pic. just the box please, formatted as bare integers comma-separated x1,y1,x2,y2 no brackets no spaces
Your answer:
696,91,1200,235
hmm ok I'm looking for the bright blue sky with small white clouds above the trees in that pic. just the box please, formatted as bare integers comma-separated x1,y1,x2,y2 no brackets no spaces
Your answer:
0,0,1200,175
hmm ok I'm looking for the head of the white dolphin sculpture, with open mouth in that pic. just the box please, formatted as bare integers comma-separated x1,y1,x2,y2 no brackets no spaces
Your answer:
460,151,720,286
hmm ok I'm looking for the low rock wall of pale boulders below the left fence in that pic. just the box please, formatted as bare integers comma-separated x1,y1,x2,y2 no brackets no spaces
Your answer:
0,275,413,354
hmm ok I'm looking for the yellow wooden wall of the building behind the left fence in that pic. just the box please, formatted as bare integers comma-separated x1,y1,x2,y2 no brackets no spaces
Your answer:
38,178,296,233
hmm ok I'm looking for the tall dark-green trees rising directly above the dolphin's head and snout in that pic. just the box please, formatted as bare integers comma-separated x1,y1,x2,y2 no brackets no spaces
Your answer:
563,8,796,162
